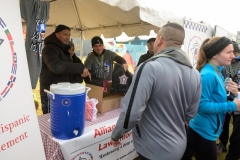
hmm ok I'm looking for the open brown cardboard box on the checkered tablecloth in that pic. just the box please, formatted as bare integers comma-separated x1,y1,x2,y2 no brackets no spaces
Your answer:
86,83,124,113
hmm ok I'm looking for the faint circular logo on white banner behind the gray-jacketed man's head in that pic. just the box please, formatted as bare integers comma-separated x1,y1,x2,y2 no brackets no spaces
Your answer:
188,36,202,66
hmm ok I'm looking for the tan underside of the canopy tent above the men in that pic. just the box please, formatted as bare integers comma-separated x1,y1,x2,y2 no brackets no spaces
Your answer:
23,0,163,39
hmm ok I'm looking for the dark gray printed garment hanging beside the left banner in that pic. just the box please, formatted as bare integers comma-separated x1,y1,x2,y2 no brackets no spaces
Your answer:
20,0,50,89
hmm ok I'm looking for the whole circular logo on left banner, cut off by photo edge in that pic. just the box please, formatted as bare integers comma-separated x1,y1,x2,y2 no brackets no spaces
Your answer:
0,17,17,102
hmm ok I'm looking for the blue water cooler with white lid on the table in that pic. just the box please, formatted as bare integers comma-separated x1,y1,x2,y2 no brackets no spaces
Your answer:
44,83,90,139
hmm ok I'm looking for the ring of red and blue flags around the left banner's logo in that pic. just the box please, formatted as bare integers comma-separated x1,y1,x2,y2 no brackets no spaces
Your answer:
0,17,17,101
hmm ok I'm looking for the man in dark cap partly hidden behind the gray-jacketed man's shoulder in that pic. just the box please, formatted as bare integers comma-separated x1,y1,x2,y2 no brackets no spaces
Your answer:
137,38,156,66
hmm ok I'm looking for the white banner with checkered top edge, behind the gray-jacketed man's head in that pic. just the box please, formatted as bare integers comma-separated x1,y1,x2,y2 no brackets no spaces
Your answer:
183,20,212,66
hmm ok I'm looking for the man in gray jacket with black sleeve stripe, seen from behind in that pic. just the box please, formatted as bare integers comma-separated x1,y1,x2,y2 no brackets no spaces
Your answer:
111,23,201,160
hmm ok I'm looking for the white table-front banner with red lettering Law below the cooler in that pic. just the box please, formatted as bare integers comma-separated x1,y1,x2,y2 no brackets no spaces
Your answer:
56,117,138,160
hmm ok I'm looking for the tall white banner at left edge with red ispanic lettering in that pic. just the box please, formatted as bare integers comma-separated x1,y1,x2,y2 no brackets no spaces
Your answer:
0,0,45,160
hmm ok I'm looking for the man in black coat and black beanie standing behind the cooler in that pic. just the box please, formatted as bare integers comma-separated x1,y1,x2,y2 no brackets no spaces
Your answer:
40,25,89,114
